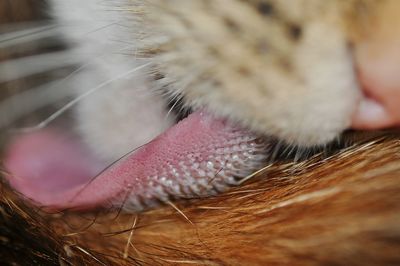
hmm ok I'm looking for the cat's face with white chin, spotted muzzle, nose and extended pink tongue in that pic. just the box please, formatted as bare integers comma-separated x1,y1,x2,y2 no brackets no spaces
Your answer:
2,0,400,212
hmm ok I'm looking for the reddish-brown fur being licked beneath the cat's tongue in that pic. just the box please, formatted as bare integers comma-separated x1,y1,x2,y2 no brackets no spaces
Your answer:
0,134,400,265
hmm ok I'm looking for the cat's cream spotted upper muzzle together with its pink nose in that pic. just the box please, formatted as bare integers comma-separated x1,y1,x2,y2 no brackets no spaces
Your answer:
145,1,400,146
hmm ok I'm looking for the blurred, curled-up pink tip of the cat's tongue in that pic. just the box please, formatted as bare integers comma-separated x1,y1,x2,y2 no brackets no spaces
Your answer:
3,129,108,209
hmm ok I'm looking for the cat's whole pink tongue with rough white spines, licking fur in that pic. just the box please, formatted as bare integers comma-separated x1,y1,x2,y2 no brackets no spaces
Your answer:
5,111,269,210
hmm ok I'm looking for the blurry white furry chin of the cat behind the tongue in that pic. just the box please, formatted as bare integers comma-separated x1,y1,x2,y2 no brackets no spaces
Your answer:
52,0,173,161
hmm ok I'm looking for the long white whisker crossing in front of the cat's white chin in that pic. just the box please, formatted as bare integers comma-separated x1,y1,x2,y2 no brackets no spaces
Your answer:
15,62,151,132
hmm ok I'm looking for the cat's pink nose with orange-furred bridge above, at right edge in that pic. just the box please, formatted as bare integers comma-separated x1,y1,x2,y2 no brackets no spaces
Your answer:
352,0,400,129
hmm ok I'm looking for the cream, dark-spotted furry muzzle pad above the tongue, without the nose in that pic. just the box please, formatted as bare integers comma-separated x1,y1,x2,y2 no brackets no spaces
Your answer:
150,1,361,146
